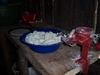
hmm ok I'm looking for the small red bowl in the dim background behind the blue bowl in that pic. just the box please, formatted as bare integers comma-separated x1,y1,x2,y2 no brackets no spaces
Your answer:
22,13,36,23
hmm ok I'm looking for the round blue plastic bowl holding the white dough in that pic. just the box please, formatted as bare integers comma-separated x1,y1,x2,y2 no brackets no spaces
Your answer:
20,29,62,53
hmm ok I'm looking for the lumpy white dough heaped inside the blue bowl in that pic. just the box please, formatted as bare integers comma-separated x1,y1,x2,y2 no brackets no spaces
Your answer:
25,31,61,45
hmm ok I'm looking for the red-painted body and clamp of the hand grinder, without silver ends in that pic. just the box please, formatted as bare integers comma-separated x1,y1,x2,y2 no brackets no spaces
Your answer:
66,27,94,74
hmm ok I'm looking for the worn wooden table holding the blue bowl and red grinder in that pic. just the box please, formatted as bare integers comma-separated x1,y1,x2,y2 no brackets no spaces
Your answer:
0,23,100,75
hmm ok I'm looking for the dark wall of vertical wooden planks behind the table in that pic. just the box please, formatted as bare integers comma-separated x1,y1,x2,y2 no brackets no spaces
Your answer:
2,0,100,31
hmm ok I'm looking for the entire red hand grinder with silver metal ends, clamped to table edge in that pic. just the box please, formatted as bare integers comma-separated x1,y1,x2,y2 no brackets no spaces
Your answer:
62,27,100,74
